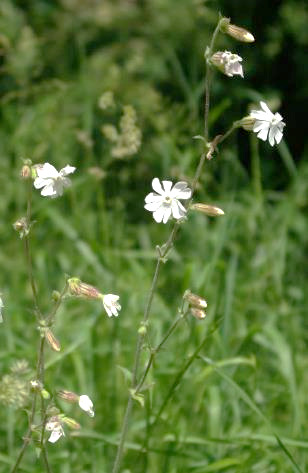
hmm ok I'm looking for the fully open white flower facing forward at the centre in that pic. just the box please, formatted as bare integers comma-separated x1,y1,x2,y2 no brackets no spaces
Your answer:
144,177,191,223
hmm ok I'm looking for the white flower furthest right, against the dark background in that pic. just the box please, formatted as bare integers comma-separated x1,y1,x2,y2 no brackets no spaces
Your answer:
250,102,285,146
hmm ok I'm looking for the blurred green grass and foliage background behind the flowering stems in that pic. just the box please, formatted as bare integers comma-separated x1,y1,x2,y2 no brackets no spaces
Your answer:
0,0,308,473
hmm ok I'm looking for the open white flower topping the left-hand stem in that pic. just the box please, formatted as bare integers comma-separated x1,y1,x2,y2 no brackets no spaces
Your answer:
33,163,76,198
